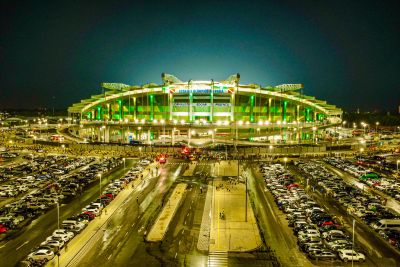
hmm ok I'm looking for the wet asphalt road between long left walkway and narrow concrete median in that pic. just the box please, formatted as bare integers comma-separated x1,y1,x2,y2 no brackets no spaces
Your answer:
74,160,182,266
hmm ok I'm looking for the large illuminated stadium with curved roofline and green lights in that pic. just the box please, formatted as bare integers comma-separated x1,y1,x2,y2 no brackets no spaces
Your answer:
68,73,342,147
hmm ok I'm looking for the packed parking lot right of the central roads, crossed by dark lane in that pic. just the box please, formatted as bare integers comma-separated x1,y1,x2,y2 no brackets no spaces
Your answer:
260,159,400,266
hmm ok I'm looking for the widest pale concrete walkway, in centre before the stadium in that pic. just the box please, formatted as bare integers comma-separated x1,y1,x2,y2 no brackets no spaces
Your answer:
209,179,262,252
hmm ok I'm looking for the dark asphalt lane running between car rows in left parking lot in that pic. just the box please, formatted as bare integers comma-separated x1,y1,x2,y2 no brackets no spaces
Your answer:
0,160,133,267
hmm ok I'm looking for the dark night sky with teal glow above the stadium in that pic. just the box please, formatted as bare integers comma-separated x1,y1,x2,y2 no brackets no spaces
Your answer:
0,0,400,110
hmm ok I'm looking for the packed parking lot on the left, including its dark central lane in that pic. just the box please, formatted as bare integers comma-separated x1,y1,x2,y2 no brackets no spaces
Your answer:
0,152,155,266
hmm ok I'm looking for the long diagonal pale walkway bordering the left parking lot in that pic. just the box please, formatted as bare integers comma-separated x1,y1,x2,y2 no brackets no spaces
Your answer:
46,163,155,267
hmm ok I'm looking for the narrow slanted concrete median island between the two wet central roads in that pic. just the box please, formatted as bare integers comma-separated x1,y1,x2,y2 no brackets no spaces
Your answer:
146,183,187,242
